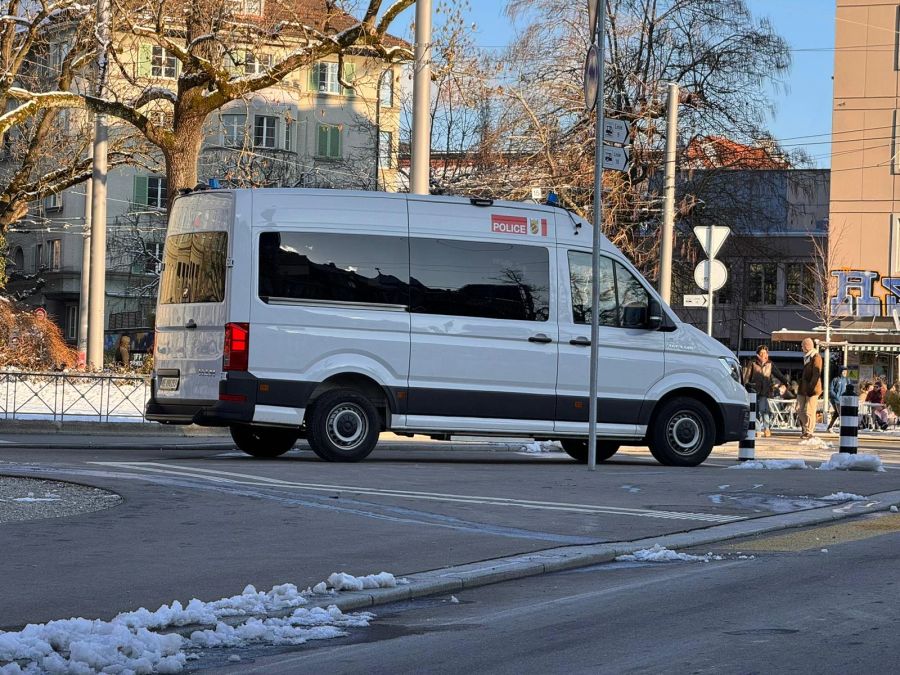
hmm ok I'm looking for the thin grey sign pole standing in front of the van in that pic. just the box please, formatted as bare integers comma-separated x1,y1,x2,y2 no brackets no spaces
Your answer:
588,0,606,471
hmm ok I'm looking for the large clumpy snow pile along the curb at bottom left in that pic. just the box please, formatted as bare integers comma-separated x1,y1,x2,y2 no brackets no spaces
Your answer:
0,572,409,675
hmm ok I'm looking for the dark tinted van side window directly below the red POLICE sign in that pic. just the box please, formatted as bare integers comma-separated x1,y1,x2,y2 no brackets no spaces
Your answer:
410,239,550,321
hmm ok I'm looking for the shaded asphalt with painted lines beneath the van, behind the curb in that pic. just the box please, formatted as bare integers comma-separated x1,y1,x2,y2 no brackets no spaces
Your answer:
0,441,900,629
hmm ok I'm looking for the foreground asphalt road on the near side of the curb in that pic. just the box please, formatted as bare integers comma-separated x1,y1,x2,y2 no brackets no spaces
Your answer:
216,515,900,675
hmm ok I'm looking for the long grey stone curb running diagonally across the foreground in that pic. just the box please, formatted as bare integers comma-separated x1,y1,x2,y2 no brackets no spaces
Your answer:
160,490,900,637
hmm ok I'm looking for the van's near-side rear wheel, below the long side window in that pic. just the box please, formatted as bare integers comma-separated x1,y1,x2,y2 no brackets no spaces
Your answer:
306,389,381,462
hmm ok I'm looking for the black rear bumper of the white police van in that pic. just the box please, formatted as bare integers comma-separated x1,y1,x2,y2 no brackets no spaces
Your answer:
144,373,257,427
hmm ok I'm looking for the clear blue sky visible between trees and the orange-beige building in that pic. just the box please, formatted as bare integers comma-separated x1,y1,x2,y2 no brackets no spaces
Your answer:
397,0,835,167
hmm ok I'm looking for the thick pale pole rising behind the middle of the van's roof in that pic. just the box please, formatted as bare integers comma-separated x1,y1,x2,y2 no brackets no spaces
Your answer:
409,0,431,195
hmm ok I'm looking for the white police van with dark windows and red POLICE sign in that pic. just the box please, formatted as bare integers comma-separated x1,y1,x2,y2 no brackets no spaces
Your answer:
147,189,748,466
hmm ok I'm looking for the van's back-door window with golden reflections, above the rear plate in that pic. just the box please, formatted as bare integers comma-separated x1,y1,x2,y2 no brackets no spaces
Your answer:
159,232,228,305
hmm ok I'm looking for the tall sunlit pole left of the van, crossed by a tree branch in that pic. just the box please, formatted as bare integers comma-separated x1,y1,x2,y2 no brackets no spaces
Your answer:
87,0,110,371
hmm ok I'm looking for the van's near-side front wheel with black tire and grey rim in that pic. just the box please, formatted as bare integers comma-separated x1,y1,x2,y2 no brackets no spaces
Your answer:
648,398,716,466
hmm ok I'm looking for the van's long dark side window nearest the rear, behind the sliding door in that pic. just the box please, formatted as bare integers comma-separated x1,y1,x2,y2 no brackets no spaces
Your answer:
259,232,409,305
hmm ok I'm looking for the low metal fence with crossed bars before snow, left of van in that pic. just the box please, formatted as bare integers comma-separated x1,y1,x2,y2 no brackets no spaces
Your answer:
0,370,150,422
